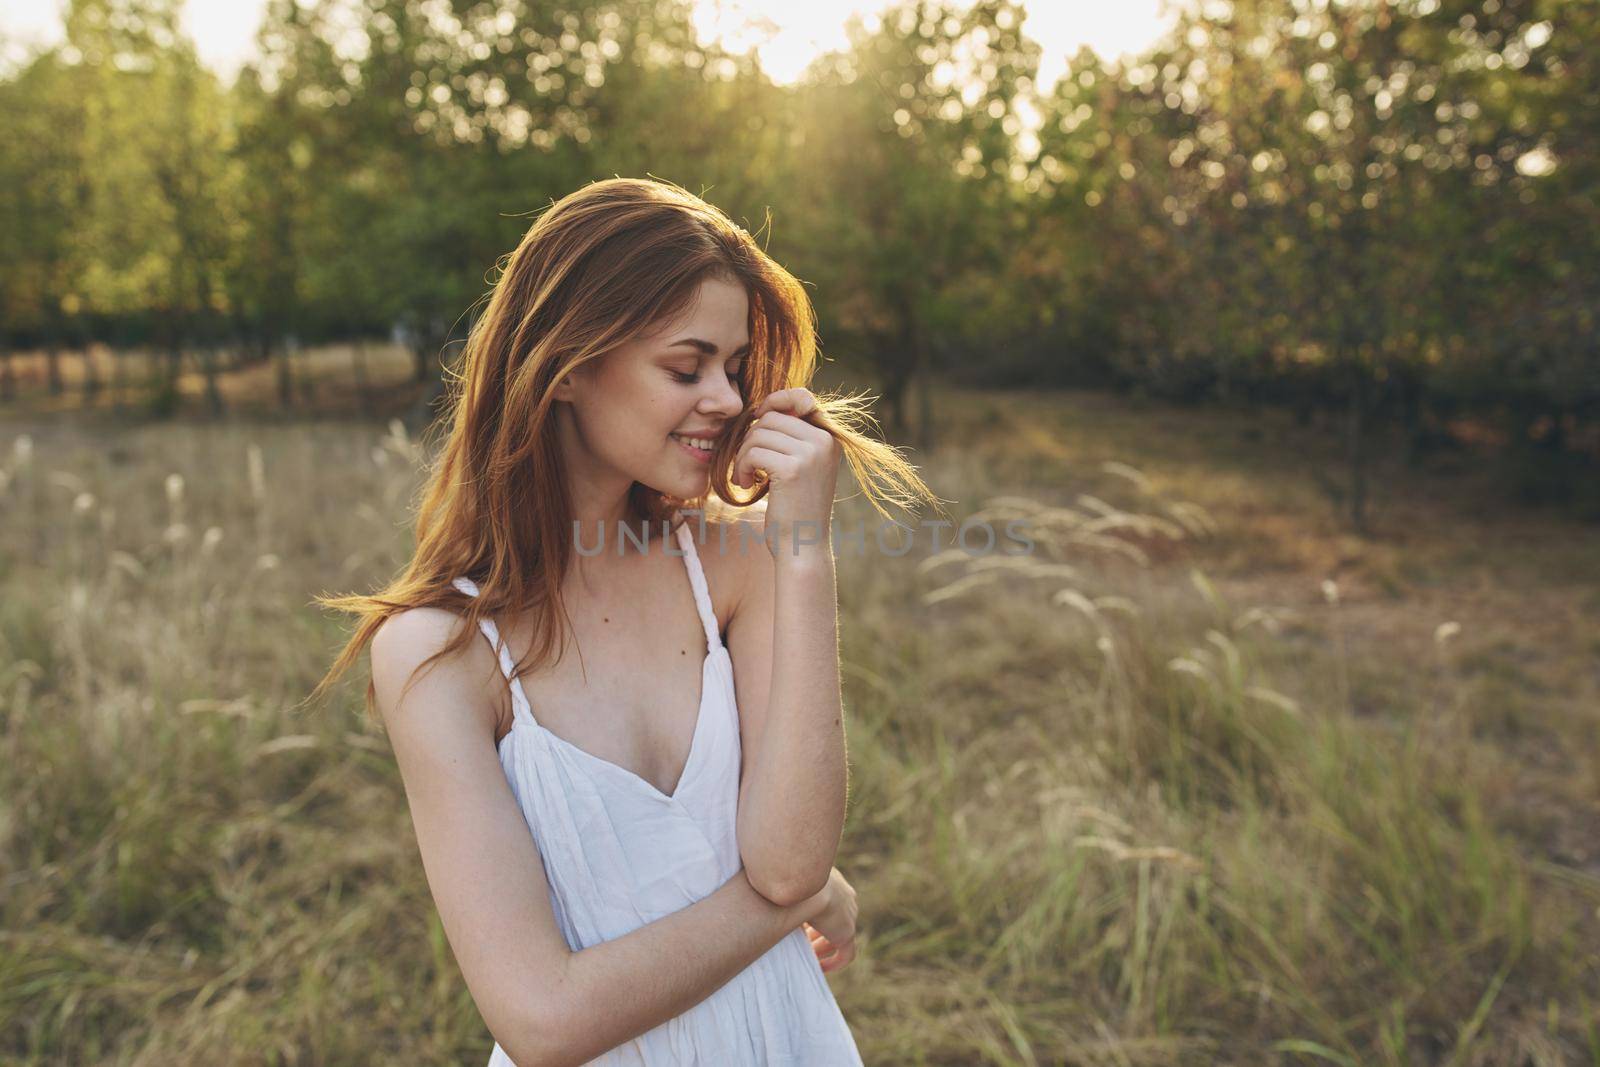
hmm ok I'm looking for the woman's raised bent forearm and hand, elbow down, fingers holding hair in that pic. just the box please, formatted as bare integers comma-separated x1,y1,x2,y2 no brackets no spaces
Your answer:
726,389,848,904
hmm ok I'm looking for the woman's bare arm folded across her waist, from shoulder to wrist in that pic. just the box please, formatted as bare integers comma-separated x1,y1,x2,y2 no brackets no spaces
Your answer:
371,608,832,1067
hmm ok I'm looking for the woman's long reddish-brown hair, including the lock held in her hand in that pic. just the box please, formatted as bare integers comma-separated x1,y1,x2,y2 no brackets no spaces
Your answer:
307,178,938,715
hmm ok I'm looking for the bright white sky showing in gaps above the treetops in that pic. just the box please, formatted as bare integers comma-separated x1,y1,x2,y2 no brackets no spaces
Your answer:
0,0,1168,90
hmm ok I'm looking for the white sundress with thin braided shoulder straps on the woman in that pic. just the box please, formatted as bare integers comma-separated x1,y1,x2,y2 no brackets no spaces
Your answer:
454,511,861,1067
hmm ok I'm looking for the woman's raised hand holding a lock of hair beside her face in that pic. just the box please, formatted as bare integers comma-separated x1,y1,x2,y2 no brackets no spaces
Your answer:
733,387,843,557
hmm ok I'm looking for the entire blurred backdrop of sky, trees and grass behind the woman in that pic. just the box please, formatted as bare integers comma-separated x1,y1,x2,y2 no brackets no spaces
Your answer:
0,0,1600,1067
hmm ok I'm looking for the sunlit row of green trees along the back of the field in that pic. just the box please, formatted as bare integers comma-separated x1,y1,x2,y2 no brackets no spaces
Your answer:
0,0,1600,511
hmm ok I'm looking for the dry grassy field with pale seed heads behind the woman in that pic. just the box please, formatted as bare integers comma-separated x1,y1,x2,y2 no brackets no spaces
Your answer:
0,363,1600,1067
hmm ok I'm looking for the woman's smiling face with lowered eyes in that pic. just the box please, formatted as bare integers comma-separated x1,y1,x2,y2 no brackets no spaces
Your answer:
555,271,750,537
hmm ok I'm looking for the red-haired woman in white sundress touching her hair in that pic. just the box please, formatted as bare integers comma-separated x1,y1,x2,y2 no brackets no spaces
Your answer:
318,179,936,1067
